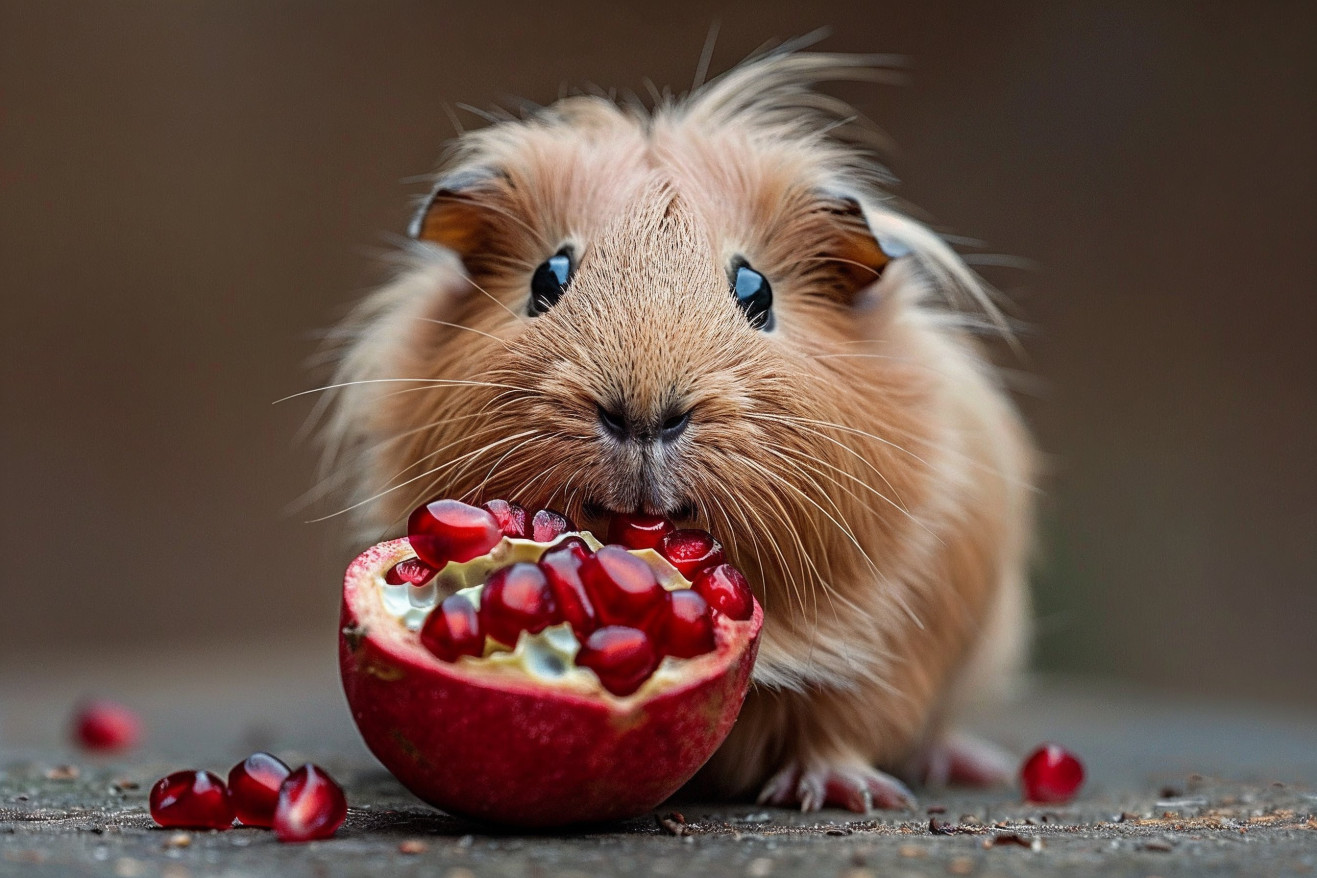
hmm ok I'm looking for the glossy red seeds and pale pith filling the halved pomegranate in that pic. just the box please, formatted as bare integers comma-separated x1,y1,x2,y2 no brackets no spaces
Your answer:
385,500,755,696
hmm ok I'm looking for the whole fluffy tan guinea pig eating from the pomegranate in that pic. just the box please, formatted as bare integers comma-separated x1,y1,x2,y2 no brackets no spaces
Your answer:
318,51,1033,811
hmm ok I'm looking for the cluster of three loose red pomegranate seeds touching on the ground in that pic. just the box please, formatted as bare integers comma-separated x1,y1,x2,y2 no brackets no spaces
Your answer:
150,753,348,841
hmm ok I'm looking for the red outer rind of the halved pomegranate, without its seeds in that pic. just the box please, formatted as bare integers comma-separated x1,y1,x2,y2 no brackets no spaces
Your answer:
338,540,764,827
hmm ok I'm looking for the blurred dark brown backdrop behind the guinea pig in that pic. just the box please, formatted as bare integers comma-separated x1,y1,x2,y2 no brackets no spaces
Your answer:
0,0,1317,704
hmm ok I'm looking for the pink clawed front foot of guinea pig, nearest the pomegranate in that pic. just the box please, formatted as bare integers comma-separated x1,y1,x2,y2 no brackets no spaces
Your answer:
759,762,914,813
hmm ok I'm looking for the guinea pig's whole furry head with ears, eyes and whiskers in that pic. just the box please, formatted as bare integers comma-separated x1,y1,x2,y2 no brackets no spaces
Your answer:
328,57,990,631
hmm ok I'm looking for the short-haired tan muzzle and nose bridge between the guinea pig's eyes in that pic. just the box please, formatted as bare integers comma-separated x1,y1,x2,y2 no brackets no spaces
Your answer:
498,184,761,519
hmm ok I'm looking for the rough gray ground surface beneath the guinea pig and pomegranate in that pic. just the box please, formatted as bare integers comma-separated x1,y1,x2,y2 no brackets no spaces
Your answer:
0,648,1317,878
